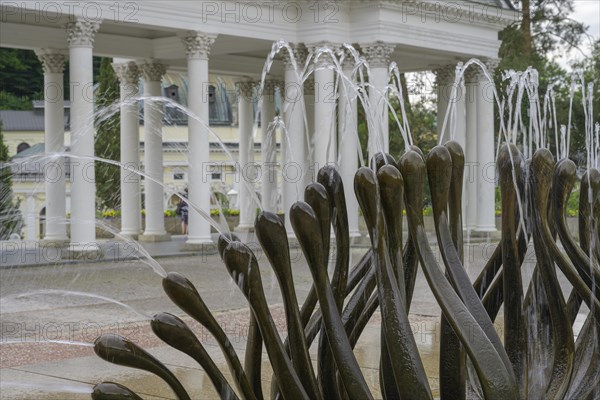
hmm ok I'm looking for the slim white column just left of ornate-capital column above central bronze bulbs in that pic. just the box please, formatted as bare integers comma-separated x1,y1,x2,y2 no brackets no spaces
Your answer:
338,54,361,238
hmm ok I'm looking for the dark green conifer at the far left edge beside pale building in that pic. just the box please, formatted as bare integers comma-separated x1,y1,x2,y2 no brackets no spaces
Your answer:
0,121,23,240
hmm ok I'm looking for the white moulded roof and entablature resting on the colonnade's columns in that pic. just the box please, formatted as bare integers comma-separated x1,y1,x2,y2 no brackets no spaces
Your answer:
0,0,519,76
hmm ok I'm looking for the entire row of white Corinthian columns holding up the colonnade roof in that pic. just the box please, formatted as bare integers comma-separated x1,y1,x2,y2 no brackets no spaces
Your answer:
37,20,494,246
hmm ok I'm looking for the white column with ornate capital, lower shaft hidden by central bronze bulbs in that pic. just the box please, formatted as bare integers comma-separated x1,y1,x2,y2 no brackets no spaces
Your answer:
360,41,396,158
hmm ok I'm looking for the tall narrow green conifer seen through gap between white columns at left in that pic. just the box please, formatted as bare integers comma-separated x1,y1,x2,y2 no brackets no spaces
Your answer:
95,58,121,209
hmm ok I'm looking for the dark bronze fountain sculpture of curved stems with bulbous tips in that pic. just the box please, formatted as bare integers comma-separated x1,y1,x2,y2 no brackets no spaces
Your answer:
92,141,600,400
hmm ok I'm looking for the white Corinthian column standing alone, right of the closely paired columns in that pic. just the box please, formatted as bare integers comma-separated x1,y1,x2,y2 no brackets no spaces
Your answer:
182,31,216,246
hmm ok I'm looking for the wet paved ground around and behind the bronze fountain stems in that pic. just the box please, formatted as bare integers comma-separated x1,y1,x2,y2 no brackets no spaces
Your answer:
0,238,588,400
